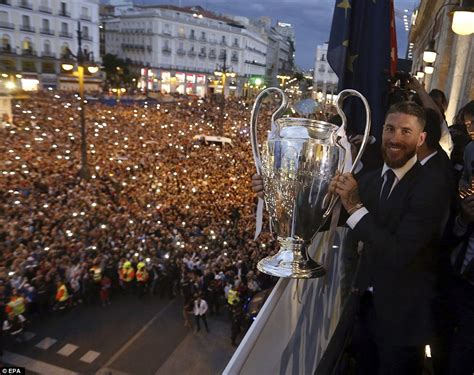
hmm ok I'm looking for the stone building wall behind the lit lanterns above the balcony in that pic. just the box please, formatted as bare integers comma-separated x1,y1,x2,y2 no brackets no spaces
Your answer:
409,0,474,125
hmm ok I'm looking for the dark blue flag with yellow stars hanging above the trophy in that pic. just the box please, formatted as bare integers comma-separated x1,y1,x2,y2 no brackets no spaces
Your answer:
327,0,397,141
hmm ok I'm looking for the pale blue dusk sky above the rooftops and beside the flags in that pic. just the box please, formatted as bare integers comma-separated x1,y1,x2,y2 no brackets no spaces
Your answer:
136,0,418,69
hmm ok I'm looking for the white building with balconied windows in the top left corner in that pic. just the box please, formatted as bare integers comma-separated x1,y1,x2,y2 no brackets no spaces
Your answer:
0,0,99,90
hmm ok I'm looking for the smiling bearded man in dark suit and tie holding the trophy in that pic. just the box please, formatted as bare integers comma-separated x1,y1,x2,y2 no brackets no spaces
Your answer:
331,102,448,375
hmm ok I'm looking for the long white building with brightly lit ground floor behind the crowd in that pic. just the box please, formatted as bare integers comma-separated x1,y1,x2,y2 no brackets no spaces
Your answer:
101,5,268,96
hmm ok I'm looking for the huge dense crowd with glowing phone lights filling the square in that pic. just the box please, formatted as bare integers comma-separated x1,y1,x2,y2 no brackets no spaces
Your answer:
0,91,275,344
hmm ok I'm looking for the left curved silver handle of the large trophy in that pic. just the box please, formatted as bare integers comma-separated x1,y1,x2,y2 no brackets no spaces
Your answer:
250,87,288,175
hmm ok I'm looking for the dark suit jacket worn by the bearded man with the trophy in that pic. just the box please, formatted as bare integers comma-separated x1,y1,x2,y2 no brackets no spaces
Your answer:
350,163,448,346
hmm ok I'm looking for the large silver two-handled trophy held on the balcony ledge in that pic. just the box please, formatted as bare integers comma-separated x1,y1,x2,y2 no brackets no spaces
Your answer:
250,87,371,279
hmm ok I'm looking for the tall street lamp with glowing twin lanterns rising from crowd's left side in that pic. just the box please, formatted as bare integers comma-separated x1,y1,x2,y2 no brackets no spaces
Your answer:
61,22,99,180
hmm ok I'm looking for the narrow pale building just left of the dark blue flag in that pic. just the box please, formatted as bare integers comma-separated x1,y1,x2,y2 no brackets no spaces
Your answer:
313,43,338,102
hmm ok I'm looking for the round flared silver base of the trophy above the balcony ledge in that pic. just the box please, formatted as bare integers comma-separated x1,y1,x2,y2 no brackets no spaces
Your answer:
257,245,326,279
